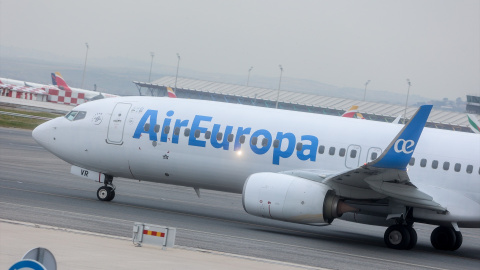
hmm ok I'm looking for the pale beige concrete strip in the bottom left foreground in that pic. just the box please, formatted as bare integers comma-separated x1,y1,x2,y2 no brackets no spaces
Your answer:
0,220,319,270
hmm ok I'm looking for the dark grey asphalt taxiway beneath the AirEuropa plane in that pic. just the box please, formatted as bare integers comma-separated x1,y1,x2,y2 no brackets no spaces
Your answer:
0,128,480,269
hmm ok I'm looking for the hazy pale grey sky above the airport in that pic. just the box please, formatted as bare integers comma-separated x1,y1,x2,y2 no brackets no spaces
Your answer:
0,0,480,99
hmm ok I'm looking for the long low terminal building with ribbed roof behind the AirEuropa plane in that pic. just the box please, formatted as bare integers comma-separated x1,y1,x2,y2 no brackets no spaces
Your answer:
134,76,471,132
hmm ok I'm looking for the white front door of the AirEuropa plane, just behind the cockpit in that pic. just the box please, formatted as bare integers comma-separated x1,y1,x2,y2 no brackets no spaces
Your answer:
107,103,132,145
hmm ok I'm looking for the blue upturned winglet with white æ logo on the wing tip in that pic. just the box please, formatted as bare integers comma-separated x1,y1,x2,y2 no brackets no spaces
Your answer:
368,105,433,170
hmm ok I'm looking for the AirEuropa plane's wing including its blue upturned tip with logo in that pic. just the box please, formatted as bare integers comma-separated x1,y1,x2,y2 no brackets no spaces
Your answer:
284,105,447,212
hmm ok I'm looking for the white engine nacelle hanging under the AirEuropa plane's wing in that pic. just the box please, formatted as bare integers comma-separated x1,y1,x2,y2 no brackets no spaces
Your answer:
242,173,346,225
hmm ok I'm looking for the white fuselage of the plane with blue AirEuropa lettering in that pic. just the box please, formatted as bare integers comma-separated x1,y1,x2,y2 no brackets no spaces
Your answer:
35,97,480,227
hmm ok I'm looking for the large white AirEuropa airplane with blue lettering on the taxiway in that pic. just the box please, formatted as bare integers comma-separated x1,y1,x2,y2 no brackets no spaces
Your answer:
32,97,480,251
